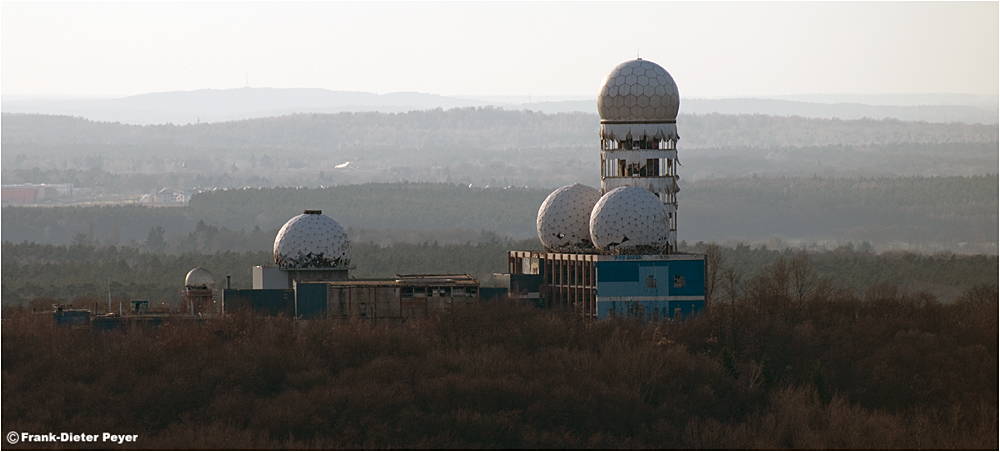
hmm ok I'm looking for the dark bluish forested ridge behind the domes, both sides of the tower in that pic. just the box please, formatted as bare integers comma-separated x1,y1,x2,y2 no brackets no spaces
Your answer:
0,176,1000,254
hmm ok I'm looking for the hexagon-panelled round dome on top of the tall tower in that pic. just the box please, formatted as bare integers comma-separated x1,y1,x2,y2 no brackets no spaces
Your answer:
597,59,680,122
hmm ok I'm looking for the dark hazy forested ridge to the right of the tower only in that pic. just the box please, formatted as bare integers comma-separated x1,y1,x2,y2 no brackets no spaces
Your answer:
678,176,1000,253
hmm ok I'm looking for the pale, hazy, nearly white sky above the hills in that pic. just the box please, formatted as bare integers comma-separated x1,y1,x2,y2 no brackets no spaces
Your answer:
0,1,1000,97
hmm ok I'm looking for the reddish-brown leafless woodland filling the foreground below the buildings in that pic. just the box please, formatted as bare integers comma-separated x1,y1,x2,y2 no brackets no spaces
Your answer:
2,278,998,450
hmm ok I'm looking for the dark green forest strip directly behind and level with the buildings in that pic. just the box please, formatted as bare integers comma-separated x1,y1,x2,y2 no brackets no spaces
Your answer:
0,240,1000,309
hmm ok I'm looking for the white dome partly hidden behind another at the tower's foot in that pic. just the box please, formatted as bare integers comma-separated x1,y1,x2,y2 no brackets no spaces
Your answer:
536,184,601,251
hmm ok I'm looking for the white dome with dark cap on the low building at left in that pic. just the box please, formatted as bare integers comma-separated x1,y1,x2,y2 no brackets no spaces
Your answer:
274,210,351,268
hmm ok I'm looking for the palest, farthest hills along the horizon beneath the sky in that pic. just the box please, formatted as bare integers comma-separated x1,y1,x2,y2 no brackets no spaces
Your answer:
0,88,1000,125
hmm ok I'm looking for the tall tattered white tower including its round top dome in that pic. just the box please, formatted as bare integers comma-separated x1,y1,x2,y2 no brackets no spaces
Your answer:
597,58,680,253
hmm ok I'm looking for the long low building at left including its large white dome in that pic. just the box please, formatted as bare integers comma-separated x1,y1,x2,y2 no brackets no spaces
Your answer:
231,210,488,320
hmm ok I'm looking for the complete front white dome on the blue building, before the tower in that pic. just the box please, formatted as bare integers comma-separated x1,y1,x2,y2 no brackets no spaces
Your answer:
590,186,670,254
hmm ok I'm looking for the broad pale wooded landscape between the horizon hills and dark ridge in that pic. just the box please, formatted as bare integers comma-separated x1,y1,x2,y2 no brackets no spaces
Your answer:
0,108,1000,187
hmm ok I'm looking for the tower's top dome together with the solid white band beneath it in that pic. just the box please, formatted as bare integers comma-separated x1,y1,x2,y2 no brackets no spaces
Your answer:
597,58,680,140
